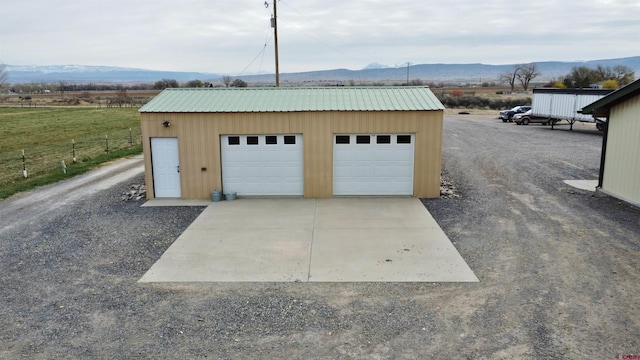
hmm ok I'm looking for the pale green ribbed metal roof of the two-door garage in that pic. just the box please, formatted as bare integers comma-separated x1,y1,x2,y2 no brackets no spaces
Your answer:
140,87,444,113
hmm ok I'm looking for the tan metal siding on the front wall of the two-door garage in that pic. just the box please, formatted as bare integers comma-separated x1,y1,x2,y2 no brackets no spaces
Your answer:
141,110,443,199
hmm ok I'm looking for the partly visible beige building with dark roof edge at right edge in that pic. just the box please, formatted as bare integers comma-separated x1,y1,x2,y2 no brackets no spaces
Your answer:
582,80,640,207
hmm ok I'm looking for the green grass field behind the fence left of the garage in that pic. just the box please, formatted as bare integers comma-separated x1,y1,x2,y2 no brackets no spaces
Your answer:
0,108,141,199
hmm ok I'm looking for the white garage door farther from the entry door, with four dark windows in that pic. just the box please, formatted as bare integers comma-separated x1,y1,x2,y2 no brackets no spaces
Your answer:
333,134,415,195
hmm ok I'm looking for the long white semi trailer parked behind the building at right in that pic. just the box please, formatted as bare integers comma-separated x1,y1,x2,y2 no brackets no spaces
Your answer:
531,88,613,130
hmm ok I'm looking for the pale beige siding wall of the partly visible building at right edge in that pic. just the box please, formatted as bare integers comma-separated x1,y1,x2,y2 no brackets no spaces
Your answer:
602,95,640,204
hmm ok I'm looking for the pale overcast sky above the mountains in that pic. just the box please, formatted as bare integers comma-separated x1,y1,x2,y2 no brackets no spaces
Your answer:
0,0,640,75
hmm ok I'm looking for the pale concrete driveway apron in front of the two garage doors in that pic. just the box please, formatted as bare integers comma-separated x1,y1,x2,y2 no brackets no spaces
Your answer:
139,197,478,282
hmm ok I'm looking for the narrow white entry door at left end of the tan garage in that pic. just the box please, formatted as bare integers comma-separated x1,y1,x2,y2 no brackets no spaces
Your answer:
151,138,182,198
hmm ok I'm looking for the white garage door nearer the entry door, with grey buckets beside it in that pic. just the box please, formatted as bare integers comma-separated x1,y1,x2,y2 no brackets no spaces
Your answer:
220,135,304,195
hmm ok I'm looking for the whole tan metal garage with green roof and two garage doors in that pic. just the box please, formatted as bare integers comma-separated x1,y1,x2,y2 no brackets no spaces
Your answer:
140,87,444,199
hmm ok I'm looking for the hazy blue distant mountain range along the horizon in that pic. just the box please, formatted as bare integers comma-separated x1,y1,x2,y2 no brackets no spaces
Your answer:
7,56,640,85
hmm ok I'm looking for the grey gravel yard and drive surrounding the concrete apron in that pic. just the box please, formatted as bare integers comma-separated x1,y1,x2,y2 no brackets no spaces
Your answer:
0,115,640,359
